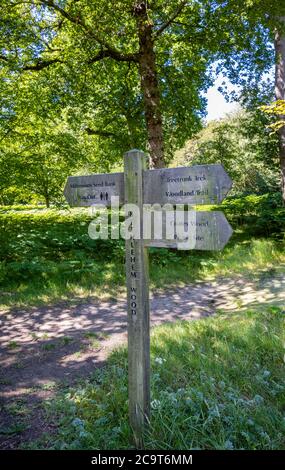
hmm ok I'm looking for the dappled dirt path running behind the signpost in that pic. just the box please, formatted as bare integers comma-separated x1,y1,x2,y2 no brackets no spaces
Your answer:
0,272,285,448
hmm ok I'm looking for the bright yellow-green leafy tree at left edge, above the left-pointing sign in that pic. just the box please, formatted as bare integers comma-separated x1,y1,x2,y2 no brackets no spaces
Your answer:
0,67,101,207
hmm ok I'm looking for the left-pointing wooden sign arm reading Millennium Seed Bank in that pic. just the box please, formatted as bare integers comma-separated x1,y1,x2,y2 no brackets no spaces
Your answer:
64,173,124,207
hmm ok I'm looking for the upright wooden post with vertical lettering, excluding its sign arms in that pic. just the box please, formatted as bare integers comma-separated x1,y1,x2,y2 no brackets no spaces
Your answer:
124,150,150,448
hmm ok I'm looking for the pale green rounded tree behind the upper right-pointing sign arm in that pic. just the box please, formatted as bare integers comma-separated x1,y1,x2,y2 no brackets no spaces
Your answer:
175,110,280,195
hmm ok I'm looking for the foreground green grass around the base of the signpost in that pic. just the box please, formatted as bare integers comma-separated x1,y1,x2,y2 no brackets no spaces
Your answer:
26,307,285,449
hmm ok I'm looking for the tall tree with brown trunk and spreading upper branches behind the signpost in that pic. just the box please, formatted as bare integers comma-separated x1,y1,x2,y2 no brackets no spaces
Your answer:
2,0,209,166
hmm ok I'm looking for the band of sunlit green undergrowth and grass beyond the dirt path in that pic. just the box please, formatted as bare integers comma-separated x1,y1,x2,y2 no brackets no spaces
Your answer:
0,200,285,308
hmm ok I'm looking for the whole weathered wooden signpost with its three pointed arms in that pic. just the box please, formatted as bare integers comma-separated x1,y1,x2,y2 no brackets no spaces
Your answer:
64,150,232,448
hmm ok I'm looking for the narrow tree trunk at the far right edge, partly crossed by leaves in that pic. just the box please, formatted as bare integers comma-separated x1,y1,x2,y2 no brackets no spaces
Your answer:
275,17,285,205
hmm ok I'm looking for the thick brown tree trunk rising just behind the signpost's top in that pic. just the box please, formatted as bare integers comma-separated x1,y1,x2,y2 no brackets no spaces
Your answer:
134,0,164,168
